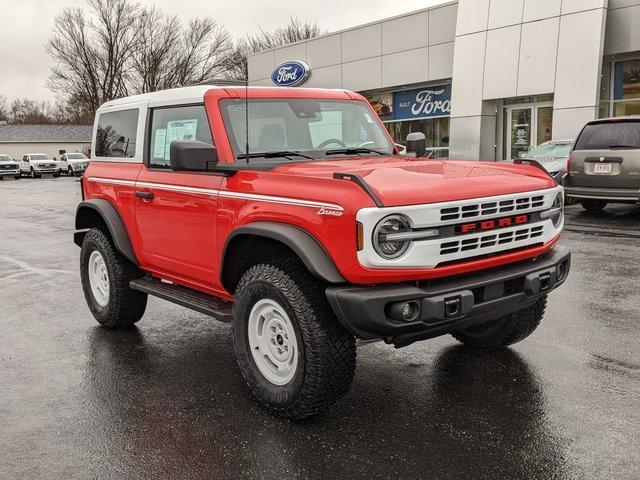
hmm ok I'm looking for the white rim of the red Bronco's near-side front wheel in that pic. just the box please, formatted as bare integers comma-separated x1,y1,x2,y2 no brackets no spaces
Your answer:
247,298,298,385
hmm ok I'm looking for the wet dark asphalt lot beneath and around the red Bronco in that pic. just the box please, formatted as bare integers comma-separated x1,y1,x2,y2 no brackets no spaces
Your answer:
0,177,640,480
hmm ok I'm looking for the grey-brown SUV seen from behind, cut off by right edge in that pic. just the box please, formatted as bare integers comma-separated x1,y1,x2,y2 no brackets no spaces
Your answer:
566,117,640,211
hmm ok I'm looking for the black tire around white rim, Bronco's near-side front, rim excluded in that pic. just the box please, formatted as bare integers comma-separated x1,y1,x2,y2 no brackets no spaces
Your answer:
233,258,356,419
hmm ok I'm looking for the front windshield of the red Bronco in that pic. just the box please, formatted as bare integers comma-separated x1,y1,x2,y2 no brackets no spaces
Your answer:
221,99,393,161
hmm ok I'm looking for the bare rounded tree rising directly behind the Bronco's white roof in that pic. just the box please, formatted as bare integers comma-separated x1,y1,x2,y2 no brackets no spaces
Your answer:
132,7,233,92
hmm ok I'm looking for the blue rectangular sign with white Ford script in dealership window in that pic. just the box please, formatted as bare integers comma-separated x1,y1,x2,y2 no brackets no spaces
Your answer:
393,85,451,120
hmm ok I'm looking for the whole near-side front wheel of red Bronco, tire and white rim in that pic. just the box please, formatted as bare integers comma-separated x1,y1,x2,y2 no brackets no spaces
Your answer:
233,259,356,419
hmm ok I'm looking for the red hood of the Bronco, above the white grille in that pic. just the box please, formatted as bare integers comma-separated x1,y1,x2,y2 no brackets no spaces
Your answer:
273,157,555,206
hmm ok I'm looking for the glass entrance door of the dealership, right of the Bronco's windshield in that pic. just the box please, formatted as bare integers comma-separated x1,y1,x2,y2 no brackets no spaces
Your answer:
505,105,553,159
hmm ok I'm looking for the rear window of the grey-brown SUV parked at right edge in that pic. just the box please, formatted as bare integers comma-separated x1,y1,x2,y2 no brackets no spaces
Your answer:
575,122,640,150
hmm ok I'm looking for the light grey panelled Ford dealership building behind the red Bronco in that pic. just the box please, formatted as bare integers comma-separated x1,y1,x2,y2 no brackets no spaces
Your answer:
249,0,640,160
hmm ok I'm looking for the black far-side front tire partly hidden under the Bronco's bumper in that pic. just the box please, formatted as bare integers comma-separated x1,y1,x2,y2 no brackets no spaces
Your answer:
451,295,547,348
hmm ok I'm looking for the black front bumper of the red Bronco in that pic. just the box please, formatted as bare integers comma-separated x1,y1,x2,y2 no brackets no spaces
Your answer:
326,246,571,347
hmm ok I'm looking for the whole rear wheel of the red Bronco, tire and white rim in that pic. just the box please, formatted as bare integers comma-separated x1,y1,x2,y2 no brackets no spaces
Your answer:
80,229,147,328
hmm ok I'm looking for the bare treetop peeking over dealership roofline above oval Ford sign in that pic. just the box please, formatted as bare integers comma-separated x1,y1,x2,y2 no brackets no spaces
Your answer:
225,18,321,80
